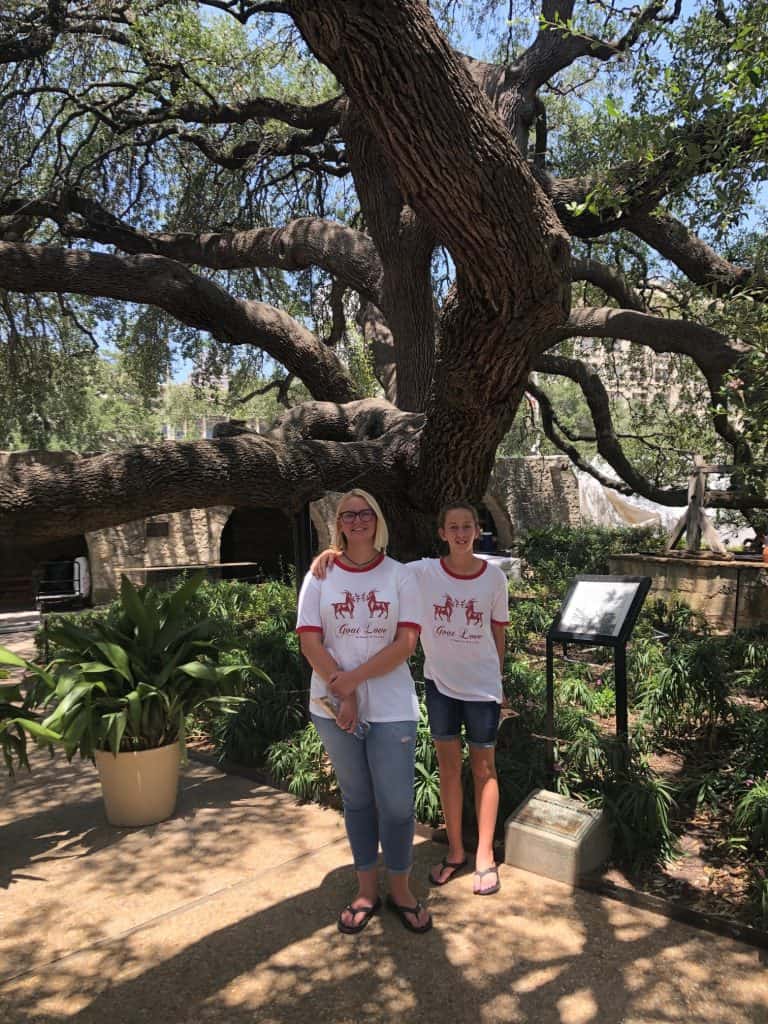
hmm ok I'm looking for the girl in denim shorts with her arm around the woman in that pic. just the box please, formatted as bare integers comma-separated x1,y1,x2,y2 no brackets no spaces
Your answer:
312,502,509,896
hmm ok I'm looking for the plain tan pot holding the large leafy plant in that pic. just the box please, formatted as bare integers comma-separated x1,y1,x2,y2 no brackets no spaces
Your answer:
95,742,181,825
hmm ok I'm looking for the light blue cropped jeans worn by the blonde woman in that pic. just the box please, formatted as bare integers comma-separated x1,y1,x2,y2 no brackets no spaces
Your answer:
311,715,416,874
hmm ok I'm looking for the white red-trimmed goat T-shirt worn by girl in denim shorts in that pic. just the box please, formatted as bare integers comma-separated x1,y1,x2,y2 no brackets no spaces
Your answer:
408,558,509,703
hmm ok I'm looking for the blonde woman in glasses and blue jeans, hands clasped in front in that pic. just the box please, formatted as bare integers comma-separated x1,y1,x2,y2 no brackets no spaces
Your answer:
297,489,432,935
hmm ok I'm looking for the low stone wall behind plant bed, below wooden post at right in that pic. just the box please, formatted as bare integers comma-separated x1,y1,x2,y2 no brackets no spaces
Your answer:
608,554,768,633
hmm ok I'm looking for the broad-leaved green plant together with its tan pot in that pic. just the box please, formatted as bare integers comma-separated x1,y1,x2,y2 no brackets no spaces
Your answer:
0,574,263,825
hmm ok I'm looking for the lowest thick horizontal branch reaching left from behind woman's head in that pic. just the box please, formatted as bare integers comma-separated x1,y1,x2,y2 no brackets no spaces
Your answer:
0,421,412,544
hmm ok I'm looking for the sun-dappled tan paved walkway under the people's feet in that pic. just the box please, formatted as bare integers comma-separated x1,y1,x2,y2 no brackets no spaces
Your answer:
0,754,768,1024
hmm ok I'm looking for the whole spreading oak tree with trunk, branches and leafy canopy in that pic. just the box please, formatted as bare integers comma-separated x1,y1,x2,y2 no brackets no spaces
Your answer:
0,0,768,551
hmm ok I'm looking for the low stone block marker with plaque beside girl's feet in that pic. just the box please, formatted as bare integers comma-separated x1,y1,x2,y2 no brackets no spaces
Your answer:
504,790,610,885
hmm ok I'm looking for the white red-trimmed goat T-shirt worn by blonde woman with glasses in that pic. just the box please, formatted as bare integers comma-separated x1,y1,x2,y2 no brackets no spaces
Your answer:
296,555,421,722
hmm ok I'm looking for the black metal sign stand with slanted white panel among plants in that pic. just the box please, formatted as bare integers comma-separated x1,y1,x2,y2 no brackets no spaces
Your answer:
547,575,651,779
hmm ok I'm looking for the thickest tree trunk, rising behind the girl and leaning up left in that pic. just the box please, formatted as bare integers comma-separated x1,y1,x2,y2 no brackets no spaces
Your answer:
290,0,570,510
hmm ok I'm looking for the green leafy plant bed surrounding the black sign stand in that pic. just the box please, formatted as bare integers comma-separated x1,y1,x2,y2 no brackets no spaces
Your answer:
499,526,768,927
